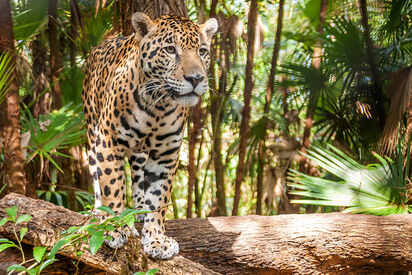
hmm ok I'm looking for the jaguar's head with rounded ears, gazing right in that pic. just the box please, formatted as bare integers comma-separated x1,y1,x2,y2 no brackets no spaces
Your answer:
132,12,218,106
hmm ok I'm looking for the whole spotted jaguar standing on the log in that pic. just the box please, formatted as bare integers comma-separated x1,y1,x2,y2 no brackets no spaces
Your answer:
82,13,217,259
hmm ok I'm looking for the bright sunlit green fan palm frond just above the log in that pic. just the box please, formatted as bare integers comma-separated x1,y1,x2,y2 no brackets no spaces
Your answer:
289,145,412,215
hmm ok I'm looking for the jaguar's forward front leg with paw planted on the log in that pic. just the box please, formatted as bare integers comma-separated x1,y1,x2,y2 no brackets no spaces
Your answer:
142,160,179,259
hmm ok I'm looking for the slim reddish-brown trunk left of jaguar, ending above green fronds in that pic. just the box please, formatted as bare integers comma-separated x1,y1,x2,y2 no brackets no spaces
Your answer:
48,0,63,109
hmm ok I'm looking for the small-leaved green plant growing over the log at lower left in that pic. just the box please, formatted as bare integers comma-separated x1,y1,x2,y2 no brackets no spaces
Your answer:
0,206,157,275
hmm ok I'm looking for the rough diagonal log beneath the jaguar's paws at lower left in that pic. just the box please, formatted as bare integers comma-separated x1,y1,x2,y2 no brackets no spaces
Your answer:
0,193,219,275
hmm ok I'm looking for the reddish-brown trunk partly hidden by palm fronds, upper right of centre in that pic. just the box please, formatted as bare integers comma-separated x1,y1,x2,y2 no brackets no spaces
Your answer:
299,0,328,172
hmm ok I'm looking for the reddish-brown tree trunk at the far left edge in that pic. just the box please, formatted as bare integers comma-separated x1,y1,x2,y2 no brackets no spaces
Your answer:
0,0,27,194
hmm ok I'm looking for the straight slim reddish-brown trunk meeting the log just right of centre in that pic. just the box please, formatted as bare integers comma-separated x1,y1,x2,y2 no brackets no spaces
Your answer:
232,0,257,216
